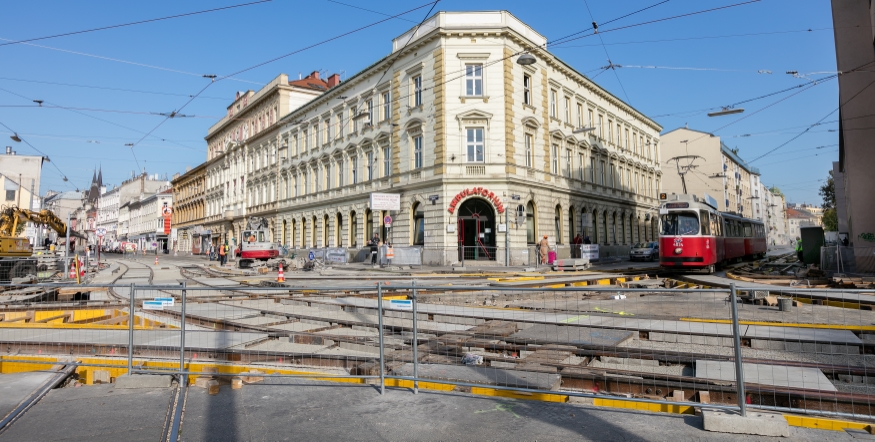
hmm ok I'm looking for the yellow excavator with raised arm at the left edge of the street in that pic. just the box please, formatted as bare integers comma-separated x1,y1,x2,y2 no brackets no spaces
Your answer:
0,206,87,281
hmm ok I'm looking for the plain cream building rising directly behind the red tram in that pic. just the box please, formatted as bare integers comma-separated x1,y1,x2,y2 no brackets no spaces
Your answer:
661,127,765,219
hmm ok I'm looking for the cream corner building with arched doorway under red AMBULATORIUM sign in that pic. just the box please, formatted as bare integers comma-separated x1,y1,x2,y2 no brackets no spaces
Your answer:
270,11,662,265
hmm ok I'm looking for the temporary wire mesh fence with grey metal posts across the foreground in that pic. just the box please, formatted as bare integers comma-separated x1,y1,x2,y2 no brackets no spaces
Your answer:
0,282,875,419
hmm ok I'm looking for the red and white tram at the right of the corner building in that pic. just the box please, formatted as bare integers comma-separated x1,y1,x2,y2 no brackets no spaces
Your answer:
659,194,767,273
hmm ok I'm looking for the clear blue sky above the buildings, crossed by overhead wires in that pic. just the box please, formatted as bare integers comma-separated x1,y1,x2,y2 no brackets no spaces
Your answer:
0,0,838,205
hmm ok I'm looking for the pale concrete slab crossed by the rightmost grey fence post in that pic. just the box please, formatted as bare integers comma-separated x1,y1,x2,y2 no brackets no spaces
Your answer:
696,360,836,391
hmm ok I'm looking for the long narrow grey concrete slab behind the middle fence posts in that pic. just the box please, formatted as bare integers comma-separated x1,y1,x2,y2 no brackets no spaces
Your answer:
393,363,561,390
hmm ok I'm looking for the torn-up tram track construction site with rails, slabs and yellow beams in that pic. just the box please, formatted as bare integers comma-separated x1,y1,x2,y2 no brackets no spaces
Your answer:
0,245,875,440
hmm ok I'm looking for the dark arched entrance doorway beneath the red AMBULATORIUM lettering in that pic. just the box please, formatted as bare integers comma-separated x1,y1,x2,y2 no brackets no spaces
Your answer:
457,198,496,261
